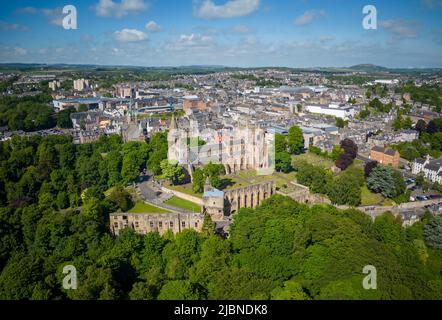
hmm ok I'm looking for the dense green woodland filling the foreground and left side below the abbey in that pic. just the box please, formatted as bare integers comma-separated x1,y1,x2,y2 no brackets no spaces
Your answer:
0,134,442,299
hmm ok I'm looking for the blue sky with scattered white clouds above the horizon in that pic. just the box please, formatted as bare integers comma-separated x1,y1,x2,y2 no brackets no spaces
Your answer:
0,0,442,68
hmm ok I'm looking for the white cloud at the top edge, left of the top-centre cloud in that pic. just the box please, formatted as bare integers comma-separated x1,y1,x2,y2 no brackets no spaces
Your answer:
94,0,149,18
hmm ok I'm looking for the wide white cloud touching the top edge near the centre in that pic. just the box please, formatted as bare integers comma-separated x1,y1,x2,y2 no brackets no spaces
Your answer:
193,0,260,19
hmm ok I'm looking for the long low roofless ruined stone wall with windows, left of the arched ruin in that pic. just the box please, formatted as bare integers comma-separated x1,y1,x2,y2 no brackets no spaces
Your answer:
110,212,204,236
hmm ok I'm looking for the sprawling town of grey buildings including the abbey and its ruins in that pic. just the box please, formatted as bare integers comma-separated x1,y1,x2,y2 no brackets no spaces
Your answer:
1,66,442,235
